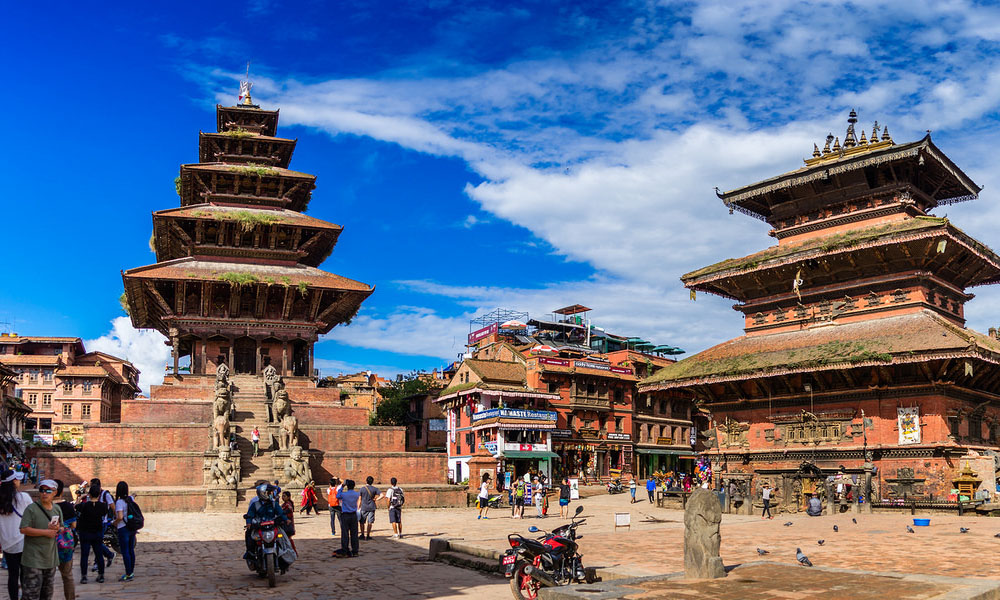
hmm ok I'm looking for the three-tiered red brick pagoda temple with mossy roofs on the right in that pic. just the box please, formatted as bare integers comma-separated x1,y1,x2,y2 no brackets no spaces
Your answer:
640,111,1000,510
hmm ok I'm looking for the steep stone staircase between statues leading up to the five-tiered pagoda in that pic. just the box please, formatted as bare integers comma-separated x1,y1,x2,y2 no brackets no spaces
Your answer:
230,375,275,500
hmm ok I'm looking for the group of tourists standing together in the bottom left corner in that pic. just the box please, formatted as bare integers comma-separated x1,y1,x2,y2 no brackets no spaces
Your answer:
0,469,143,600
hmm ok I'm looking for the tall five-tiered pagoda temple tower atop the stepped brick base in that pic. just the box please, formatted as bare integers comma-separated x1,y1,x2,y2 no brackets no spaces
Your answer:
123,94,373,383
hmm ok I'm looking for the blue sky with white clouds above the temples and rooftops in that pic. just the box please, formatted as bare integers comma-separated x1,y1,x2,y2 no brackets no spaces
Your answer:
0,0,1000,394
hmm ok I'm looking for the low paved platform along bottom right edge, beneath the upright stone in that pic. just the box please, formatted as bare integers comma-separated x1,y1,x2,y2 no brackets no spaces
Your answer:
540,562,1000,600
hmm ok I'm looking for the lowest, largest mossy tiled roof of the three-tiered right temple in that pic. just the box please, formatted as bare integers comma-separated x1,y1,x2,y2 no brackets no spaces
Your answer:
639,310,1000,391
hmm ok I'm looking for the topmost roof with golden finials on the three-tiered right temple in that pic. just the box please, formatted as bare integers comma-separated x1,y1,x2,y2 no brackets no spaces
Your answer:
717,119,982,222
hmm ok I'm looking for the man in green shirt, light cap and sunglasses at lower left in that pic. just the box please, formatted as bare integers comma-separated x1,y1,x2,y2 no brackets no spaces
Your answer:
21,479,63,600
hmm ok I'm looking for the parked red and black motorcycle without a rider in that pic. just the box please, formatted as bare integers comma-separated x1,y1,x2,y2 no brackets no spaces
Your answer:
500,506,596,600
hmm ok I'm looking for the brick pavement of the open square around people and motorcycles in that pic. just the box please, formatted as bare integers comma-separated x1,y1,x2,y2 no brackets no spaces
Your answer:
43,495,1000,600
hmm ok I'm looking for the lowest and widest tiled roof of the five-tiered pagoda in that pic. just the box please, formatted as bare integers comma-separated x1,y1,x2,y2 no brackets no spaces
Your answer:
125,257,374,294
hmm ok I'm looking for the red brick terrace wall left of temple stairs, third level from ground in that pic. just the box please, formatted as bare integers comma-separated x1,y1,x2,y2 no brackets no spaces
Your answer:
84,423,212,452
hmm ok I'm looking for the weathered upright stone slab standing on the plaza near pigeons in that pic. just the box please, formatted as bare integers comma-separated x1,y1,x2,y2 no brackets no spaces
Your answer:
684,488,726,579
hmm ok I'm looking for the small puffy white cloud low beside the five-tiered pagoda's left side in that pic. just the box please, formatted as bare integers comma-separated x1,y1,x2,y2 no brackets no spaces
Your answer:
84,317,170,395
